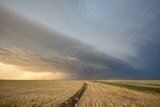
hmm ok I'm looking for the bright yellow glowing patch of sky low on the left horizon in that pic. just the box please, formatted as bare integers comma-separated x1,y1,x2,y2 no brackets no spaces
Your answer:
0,63,69,80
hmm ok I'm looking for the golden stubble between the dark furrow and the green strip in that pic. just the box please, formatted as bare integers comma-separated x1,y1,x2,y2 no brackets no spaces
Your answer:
78,82,160,107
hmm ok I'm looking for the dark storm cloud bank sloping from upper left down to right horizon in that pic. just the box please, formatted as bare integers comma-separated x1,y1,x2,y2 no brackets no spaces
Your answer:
0,9,159,79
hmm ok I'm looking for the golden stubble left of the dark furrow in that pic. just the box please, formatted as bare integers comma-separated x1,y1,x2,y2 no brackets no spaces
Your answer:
0,81,83,107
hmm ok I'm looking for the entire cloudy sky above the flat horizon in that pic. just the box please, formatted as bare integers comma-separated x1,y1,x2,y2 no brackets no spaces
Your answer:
0,0,160,79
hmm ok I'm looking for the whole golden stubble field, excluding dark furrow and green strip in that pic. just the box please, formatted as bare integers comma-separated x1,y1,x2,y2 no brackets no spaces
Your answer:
0,80,160,107
